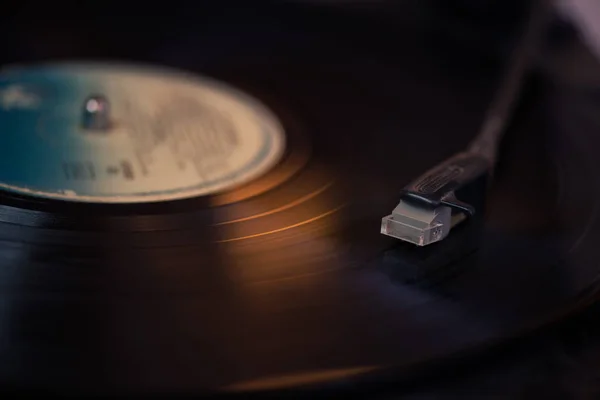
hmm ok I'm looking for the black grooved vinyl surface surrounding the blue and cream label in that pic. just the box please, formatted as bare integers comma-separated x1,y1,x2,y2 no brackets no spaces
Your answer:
0,2,600,394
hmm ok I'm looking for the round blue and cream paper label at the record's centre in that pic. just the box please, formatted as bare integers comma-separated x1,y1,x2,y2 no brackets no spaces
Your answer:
0,64,285,203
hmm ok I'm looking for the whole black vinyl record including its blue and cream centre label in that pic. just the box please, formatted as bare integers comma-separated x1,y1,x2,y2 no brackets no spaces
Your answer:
0,0,599,394
